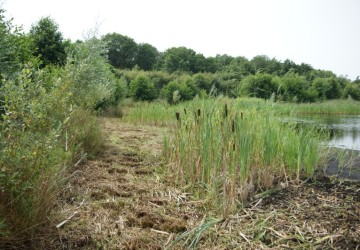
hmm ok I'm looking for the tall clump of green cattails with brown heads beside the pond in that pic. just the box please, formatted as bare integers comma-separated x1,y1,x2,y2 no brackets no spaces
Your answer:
164,99,320,216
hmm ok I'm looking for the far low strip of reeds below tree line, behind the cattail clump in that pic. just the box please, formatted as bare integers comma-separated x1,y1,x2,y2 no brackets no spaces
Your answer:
122,97,360,126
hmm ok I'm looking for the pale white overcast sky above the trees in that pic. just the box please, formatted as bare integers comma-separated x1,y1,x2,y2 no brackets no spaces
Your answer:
0,0,360,80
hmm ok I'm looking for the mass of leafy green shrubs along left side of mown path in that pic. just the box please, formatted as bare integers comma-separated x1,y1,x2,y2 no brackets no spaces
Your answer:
0,35,111,249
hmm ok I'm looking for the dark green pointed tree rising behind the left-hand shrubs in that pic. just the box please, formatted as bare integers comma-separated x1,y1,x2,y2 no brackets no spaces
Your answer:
30,17,66,67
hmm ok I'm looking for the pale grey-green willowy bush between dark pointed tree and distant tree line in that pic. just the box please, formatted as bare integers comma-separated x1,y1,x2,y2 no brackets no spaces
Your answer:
65,37,119,109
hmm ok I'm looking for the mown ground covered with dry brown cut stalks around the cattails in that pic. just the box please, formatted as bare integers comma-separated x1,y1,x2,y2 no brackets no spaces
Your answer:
44,118,360,249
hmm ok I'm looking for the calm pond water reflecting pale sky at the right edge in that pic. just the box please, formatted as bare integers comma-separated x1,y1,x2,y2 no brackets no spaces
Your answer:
286,115,360,151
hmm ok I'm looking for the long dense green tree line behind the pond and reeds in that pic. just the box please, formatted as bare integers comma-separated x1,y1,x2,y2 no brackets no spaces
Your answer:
102,33,360,103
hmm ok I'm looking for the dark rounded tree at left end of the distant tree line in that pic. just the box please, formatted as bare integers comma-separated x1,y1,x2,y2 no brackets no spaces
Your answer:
102,33,139,69
